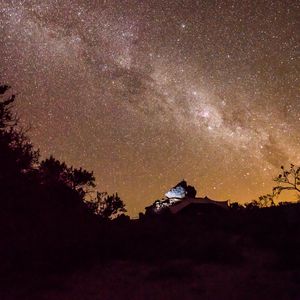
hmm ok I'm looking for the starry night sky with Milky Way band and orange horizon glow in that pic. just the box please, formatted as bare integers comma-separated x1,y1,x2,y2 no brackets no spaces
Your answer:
0,0,300,216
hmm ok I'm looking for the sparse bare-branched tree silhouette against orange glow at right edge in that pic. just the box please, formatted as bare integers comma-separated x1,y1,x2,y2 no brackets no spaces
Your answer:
273,164,300,196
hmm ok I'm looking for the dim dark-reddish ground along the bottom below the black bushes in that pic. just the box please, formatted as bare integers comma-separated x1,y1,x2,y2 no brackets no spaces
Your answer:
0,251,300,300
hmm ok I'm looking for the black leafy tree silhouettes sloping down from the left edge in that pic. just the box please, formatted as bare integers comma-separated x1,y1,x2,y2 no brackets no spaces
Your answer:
0,85,126,219
